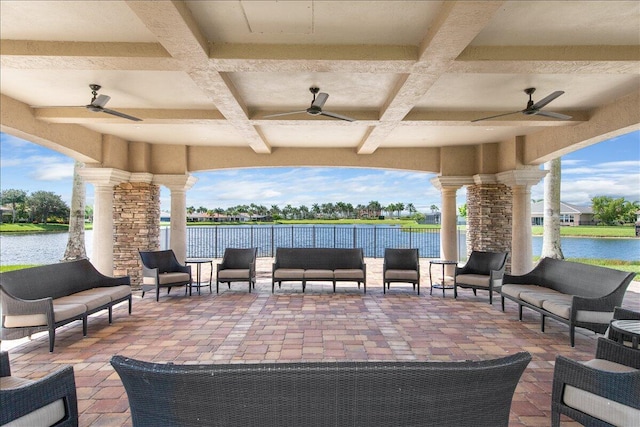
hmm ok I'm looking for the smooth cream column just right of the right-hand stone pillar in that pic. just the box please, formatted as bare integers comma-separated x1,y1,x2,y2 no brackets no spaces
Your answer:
497,169,547,275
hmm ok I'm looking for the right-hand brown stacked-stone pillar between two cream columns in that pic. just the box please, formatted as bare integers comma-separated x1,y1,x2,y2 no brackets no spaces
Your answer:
466,175,512,264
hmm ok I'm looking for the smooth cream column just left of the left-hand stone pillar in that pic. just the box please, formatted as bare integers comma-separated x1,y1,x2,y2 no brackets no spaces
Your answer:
78,168,130,276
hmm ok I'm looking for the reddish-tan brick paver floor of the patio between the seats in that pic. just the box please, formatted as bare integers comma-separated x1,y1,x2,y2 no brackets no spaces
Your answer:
2,258,640,426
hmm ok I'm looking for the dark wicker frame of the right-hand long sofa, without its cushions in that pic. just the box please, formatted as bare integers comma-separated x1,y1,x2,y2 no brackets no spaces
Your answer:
501,258,635,347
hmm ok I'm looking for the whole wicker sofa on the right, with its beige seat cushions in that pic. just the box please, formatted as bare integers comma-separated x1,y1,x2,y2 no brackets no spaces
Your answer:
500,258,635,347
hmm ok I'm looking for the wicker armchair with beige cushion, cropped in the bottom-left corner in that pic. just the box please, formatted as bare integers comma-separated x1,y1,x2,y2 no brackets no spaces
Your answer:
0,351,78,427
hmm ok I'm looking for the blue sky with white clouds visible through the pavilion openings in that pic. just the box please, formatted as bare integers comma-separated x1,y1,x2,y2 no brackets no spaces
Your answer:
0,131,640,212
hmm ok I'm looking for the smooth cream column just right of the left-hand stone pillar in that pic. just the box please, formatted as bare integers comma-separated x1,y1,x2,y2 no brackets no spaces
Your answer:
153,175,197,263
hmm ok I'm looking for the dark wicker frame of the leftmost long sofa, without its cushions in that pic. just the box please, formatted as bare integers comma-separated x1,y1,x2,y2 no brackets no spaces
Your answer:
0,259,131,351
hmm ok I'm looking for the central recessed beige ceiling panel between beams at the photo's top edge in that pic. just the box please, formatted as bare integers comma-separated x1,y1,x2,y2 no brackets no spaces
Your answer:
187,1,442,46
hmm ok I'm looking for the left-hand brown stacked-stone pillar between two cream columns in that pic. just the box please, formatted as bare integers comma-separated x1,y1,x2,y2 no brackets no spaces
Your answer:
113,174,160,285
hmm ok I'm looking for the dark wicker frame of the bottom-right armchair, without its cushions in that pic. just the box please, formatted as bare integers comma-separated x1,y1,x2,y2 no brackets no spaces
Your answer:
551,338,640,427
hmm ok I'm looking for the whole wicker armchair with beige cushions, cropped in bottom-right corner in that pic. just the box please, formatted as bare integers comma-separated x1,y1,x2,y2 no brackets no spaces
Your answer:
551,338,640,427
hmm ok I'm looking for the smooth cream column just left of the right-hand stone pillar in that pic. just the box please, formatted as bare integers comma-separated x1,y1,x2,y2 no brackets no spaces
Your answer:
431,176,473,275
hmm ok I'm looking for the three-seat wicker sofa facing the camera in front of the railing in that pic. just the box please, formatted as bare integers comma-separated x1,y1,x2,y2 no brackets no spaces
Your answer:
271,248,367,293
